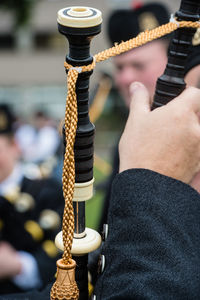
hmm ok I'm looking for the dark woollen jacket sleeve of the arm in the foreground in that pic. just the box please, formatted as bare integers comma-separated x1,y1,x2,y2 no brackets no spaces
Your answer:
95,169,200,300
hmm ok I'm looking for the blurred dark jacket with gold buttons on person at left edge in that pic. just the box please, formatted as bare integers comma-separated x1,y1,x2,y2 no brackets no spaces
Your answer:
0,178,64,294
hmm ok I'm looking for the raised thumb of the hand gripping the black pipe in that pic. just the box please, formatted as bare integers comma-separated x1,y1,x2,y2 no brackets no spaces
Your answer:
130,81,151,116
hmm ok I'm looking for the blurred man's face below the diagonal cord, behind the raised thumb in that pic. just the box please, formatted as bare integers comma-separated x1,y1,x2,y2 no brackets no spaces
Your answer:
114,41,167,107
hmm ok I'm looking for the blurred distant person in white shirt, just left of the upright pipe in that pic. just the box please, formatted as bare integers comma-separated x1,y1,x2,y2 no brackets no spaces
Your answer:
15,111,62,182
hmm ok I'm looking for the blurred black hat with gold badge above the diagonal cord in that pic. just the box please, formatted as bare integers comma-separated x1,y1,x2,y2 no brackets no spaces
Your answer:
108,3,169,44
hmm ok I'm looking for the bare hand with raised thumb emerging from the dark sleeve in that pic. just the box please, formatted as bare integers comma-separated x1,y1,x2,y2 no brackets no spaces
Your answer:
119,82,200,183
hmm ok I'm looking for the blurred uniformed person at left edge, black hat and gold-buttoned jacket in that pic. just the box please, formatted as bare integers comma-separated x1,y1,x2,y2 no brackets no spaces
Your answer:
0,105,64,294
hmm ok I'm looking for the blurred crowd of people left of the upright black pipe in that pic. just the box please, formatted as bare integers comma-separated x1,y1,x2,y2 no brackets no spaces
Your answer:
0,103,64,294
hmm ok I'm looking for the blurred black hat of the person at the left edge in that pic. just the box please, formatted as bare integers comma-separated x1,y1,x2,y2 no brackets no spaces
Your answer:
0,103,15,134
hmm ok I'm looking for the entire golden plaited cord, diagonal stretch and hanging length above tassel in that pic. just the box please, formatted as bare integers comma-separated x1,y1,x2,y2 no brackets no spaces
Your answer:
63,20,200,264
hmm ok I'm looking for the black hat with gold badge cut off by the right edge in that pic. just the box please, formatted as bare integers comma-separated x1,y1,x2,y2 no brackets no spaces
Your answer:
185,28,200,74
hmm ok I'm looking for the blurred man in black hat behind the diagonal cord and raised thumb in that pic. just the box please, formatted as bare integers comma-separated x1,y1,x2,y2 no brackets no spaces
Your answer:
99,2,170,231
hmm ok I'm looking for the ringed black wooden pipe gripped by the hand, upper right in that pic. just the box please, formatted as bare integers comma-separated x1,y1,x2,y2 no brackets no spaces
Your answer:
152,0,200,109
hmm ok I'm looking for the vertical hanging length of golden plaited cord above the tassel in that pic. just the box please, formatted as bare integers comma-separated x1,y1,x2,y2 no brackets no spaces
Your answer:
62,69,78,264
